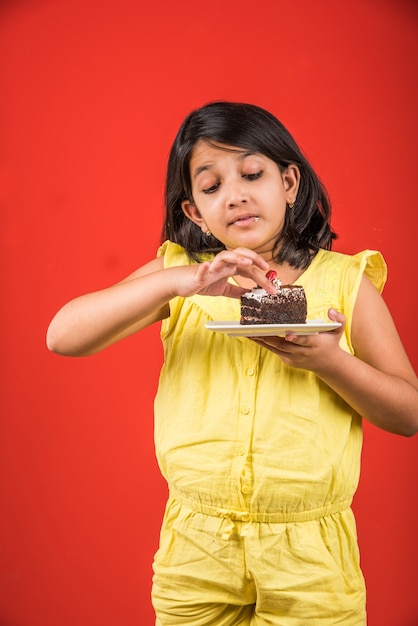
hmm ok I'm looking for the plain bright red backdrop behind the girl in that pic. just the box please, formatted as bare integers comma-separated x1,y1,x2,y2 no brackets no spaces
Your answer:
0,0,418,626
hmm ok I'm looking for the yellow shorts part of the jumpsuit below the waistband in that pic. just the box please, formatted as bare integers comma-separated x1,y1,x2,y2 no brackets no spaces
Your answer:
152,498,366,626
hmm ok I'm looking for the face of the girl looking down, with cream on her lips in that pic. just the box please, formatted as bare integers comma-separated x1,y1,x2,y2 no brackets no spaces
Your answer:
182,140,300,260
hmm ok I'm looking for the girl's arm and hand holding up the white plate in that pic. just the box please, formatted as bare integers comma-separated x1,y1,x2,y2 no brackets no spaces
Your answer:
253,276,418,436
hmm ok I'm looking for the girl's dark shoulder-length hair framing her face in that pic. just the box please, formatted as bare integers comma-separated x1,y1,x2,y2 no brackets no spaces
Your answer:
162,102,337,268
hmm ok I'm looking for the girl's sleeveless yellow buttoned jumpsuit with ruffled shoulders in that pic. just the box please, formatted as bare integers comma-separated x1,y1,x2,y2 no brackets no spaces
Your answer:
152,242,386,626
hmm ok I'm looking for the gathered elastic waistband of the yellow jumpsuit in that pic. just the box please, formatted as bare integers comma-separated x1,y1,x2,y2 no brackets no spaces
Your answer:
170,490,352,524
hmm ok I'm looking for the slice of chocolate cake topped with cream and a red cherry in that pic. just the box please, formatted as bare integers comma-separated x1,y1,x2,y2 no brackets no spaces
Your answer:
240,270,307,324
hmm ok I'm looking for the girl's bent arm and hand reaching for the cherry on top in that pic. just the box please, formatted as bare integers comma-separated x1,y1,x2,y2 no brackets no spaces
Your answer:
47,249,272,356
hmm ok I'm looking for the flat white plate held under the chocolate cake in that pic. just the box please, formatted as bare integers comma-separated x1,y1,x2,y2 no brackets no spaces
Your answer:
206,320,341,337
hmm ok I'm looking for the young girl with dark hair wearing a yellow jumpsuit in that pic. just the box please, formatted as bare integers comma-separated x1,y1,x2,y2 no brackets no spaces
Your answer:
47,102,418,626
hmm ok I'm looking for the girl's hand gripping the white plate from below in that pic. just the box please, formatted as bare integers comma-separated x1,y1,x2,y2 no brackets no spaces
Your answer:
252,309,346,372
